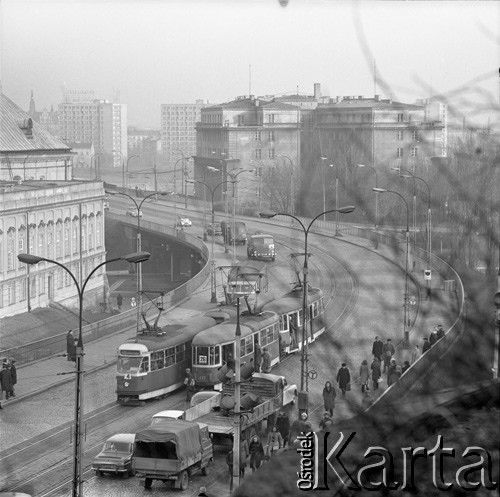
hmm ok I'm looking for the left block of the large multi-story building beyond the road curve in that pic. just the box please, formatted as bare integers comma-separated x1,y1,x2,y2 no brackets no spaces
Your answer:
194,96,302,211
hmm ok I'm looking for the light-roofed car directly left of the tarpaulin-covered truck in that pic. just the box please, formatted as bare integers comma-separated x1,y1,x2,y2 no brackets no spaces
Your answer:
92,433,135,476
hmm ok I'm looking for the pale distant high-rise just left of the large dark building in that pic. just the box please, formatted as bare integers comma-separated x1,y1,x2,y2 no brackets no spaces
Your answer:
161,100,208,168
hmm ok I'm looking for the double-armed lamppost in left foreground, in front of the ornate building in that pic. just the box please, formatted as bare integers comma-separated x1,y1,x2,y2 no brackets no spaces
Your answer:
17,252,151,497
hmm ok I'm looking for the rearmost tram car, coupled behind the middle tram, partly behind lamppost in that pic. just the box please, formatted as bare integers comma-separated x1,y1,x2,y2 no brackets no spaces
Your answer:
263,287,325,358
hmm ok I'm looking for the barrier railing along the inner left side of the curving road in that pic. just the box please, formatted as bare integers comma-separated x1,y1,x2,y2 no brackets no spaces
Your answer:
0,213,210,366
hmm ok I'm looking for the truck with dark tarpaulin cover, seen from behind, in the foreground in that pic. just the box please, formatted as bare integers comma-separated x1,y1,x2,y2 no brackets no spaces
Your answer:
132,419,213,490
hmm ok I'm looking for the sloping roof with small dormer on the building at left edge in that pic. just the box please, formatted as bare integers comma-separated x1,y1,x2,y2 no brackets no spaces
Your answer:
0,93,70,153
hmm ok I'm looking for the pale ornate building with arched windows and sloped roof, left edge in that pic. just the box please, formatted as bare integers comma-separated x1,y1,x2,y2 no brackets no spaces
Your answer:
0,94,106,318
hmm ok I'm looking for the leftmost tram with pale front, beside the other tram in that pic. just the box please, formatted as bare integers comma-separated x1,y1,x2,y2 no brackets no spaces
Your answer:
116,316,218,405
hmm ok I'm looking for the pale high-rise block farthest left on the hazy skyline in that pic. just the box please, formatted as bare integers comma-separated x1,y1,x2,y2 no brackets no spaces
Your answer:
59,90,127,168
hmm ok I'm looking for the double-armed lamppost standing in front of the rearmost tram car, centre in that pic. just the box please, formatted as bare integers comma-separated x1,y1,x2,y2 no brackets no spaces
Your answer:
259,205,355,411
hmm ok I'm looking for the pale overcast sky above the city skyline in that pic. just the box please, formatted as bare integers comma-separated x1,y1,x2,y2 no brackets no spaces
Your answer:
0,0,500,127
